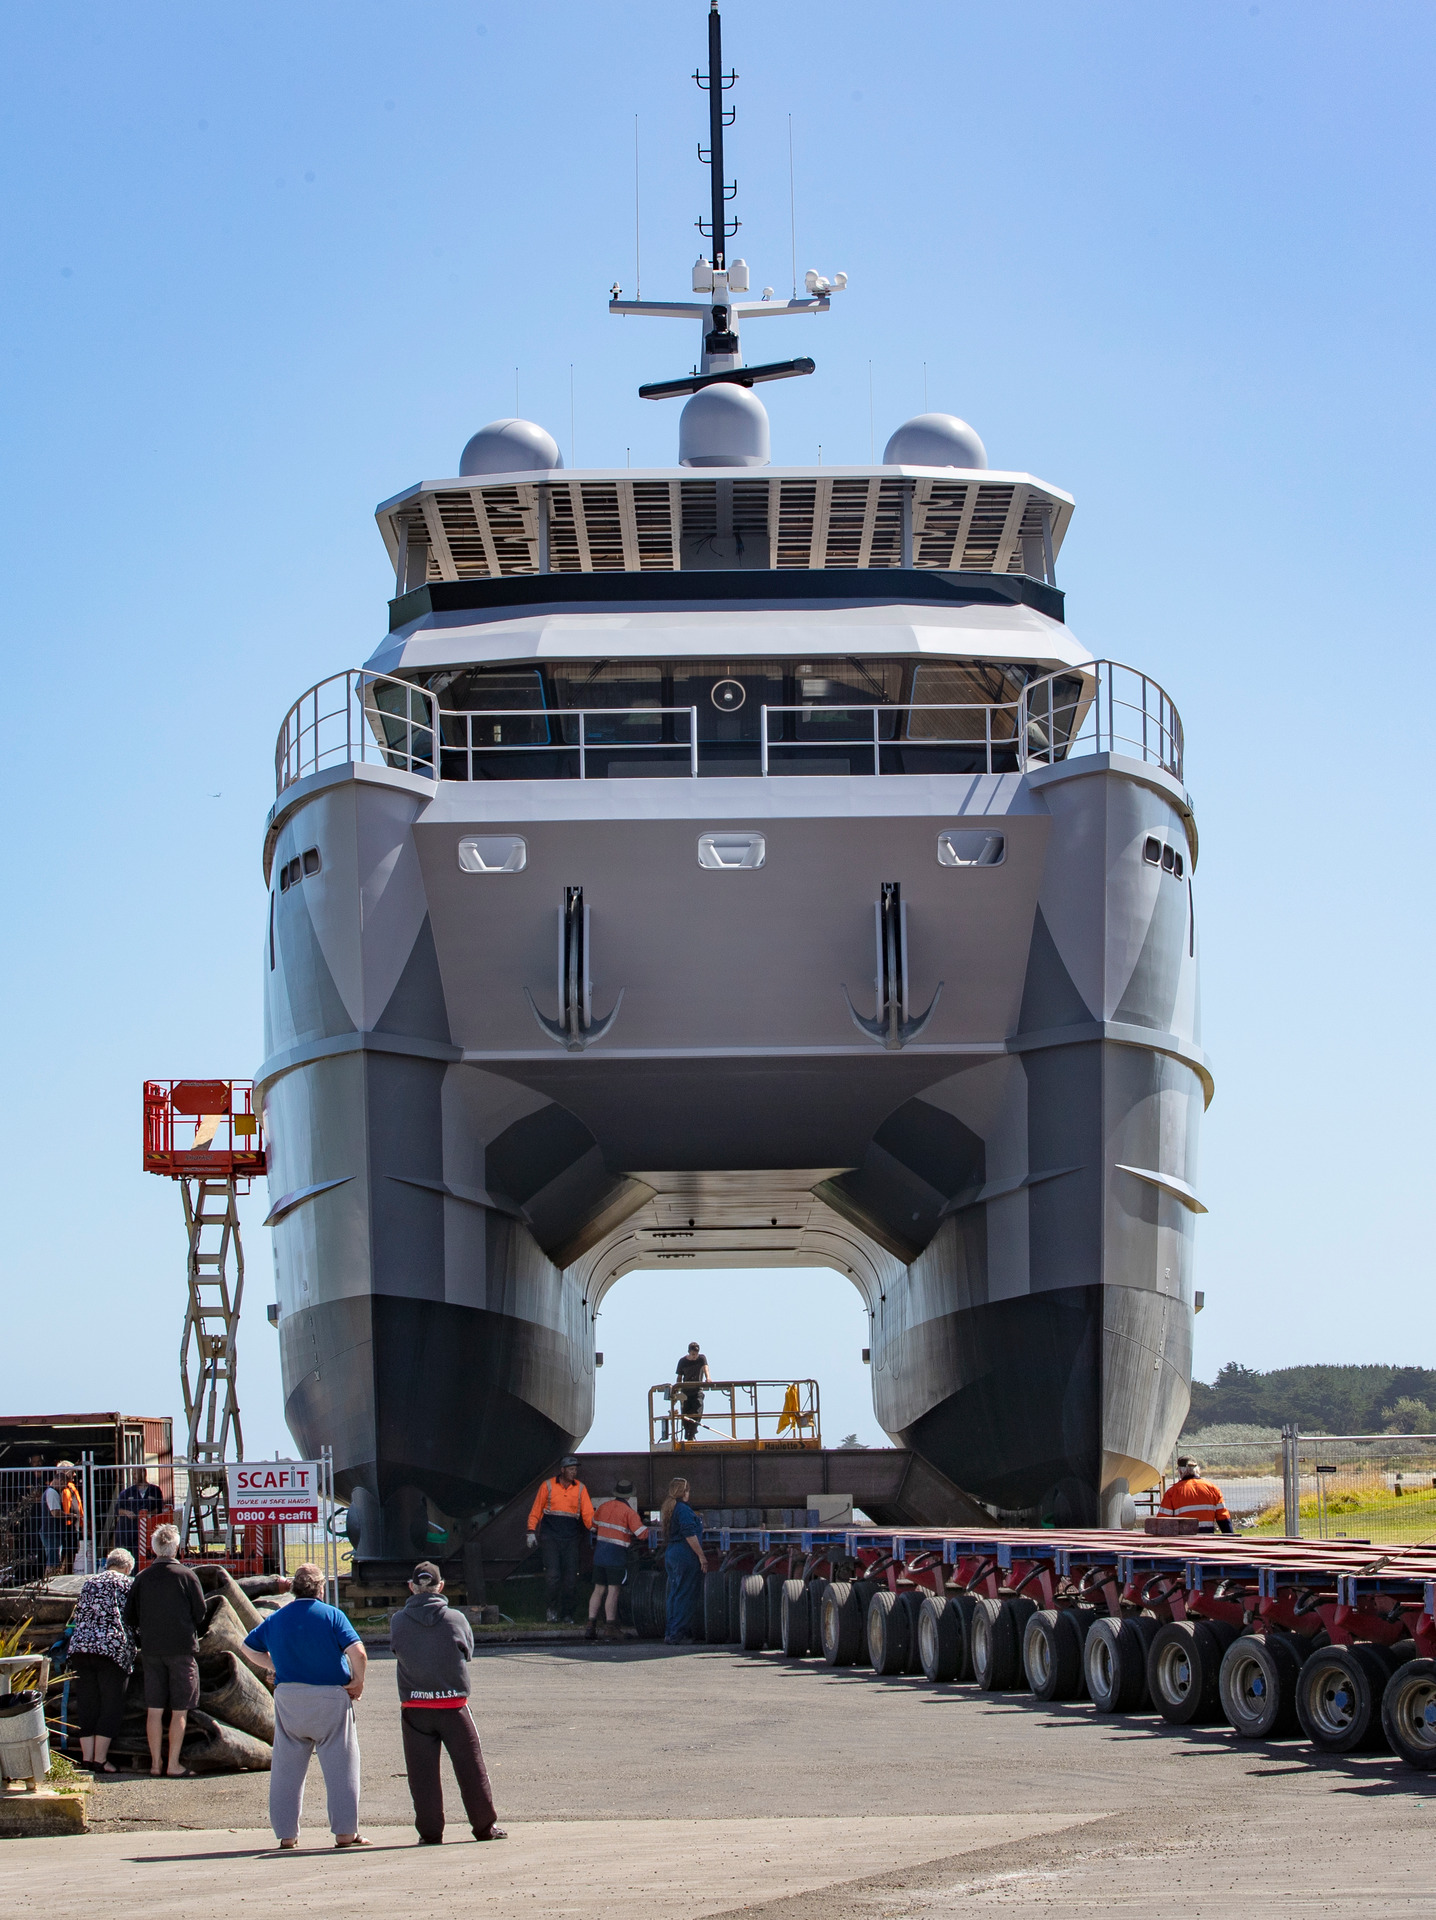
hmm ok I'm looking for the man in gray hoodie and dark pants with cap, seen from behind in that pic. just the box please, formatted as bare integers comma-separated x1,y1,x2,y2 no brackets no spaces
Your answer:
390,1561,509,1847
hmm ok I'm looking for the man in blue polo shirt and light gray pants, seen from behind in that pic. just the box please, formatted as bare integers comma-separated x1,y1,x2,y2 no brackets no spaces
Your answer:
244,1567,369,1851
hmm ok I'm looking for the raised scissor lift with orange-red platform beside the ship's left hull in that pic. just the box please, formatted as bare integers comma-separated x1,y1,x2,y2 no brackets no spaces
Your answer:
144,1081,265,1553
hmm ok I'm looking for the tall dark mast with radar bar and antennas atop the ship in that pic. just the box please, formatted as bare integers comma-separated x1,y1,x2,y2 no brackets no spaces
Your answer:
609,0,849,399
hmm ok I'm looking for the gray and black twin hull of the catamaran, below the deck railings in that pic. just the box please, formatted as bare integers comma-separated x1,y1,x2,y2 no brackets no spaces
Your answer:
261,729,1209,1559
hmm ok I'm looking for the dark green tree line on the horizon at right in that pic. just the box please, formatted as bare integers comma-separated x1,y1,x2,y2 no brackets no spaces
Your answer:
1183,1359,1436,1434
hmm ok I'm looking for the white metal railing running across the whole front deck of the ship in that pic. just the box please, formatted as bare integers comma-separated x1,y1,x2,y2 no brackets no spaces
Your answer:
275,660,1183,793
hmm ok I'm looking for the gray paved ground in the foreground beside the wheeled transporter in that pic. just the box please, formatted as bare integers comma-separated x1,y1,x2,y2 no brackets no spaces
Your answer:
0,1644,1436,1920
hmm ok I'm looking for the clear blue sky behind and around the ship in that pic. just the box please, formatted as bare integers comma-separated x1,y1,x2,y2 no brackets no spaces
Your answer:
0,0,1436,1452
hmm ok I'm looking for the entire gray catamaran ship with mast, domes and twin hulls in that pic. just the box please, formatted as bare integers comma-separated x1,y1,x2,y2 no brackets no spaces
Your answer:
257,10,1211,1561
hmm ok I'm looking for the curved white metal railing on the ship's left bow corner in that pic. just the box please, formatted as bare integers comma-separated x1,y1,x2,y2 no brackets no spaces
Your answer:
275,668,438,793
